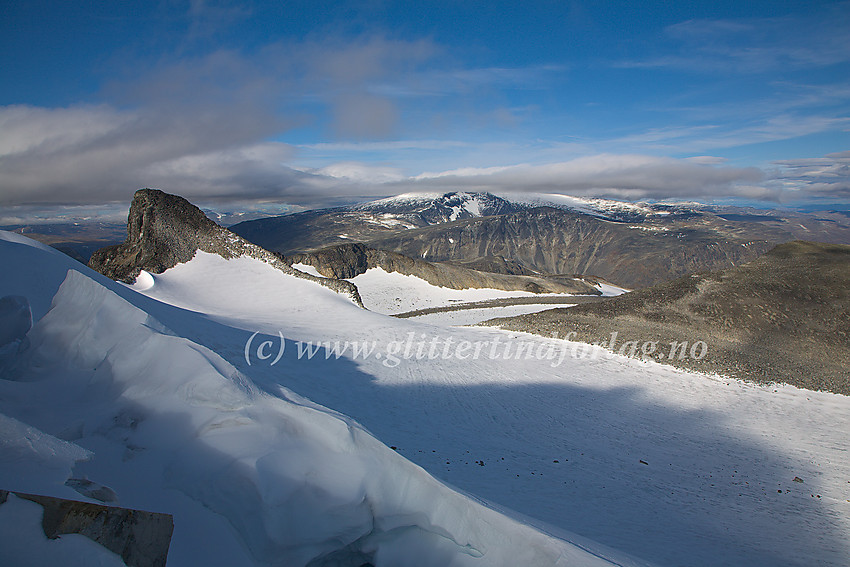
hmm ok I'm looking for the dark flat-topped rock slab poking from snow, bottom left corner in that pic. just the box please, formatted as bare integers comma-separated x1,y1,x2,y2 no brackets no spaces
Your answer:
0,490,174,567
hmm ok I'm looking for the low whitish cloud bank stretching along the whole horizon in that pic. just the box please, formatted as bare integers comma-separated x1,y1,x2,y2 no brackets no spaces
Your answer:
0,96,850,205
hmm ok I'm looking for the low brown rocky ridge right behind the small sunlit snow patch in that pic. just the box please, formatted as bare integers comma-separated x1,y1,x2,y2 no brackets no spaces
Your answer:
288,243,600,295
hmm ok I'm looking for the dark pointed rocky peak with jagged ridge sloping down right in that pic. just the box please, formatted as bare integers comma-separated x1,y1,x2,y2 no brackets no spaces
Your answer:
89,189,362,306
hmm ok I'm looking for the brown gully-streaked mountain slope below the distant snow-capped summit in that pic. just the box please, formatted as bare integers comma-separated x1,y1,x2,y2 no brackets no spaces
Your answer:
368,207,772,289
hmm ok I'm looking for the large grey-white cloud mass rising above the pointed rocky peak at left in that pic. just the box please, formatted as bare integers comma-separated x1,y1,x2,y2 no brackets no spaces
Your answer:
0,35,448,205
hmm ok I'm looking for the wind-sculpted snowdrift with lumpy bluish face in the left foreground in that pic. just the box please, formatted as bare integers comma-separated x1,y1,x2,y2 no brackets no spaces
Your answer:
0,264,608,566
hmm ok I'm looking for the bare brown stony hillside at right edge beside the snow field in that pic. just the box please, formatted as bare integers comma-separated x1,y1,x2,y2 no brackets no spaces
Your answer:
483,241,850,395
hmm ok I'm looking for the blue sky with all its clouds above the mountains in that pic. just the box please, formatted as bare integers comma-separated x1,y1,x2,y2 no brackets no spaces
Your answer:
0,0,850,216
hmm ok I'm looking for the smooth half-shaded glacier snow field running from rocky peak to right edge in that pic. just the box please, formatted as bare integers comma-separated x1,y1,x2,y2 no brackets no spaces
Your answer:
127,248,850,565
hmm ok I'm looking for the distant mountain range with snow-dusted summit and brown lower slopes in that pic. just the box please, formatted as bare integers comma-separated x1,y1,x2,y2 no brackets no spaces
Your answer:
230,193,850,288
